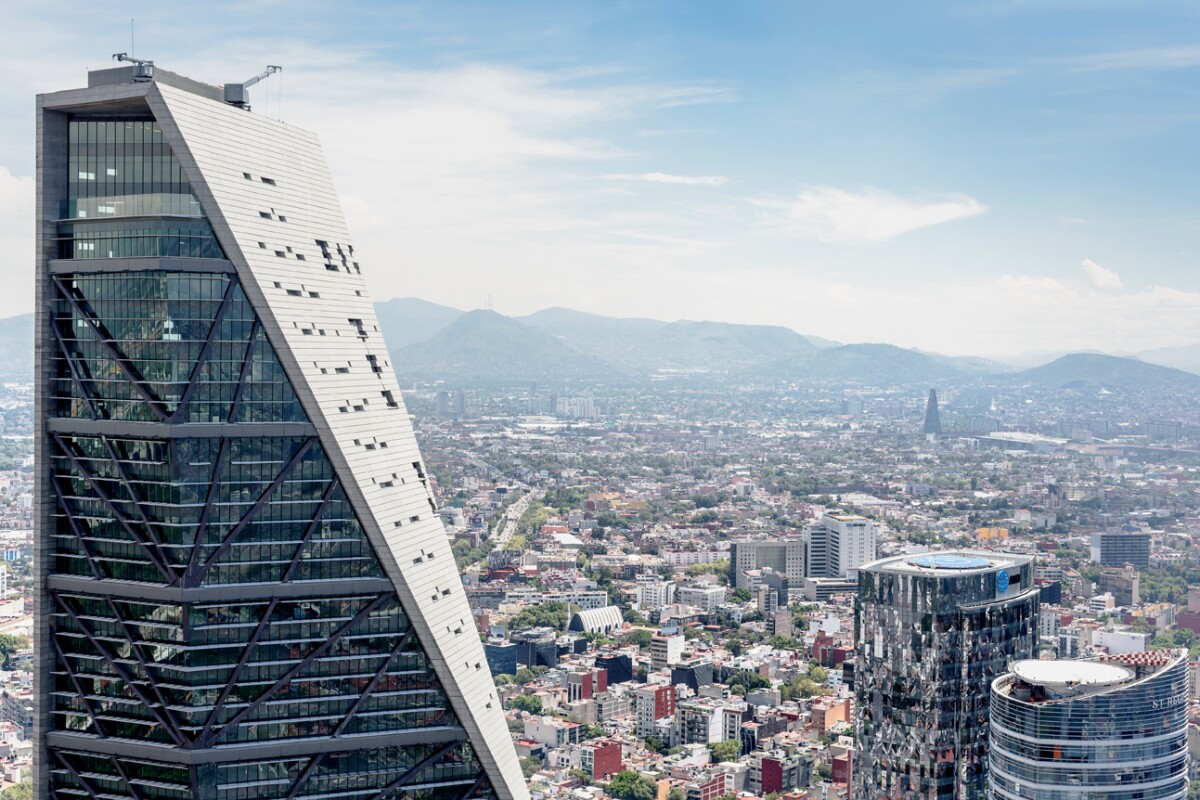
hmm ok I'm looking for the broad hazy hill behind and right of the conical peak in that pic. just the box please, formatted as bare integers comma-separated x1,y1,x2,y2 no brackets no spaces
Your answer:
520,308,816,375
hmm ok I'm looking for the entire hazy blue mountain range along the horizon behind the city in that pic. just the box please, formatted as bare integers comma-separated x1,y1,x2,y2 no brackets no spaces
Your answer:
0,297,1200,390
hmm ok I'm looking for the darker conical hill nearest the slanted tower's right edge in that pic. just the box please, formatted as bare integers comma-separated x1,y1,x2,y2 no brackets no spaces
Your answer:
388,311,614,384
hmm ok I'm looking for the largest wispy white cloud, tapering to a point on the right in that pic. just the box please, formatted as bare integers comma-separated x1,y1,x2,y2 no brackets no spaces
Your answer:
754,186,986,245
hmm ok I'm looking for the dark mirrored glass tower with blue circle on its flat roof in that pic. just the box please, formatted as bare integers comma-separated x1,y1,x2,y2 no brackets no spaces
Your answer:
853,551,1039,800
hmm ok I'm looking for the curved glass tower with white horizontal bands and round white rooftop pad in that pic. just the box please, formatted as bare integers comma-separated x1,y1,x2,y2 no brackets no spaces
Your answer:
988,650,1189,800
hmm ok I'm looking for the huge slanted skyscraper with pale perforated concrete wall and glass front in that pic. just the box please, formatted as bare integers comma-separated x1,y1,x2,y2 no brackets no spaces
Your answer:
35,62,528,800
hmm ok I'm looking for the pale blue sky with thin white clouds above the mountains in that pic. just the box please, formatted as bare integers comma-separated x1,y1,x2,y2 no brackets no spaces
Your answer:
0,0,1200,356
